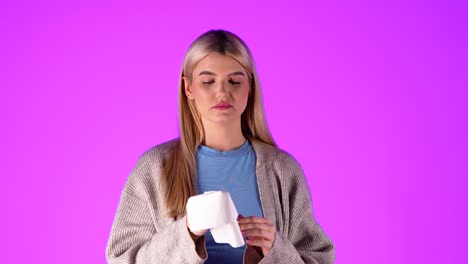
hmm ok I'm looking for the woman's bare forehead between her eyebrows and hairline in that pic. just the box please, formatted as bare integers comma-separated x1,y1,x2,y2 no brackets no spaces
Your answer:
193,52,246,76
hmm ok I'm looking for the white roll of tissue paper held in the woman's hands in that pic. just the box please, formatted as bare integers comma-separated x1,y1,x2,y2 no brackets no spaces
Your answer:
187,191,244,248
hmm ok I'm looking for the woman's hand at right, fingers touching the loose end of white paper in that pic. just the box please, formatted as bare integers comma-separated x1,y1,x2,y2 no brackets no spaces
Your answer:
237,215,276,256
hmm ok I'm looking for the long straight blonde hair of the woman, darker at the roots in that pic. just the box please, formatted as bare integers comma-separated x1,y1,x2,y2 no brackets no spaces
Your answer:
162,30,276,217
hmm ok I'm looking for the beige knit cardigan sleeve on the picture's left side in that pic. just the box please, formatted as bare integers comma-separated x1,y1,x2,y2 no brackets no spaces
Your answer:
106,150,207,264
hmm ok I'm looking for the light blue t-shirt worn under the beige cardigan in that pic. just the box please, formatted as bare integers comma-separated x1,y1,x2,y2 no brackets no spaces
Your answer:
196,141,263,264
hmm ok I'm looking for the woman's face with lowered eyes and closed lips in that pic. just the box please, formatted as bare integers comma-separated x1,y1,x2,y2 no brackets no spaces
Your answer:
184,52,250,126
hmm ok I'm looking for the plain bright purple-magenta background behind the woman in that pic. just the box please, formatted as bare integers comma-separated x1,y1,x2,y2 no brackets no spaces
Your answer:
0,0,468,264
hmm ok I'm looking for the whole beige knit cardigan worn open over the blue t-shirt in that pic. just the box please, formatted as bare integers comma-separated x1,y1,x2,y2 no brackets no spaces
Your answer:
106,139,335,264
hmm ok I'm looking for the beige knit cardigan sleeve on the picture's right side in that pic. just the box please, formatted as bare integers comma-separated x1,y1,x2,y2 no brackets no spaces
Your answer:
254,157,335,264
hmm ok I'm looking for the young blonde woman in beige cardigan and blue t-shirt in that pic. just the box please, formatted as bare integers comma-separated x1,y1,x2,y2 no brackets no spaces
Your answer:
107,30,334,264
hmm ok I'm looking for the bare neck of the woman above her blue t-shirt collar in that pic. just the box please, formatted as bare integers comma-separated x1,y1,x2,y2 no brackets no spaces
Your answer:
203,119,246,151
